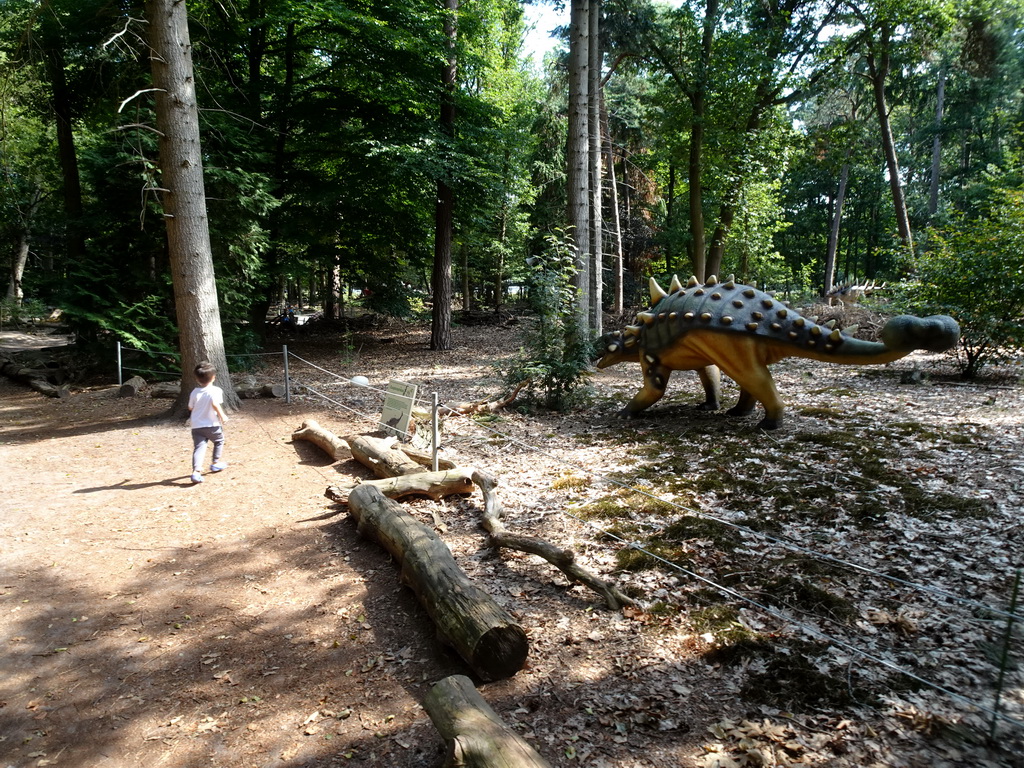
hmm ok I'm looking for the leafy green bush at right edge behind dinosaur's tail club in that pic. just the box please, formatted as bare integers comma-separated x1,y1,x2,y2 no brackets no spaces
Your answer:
903,190,1024,378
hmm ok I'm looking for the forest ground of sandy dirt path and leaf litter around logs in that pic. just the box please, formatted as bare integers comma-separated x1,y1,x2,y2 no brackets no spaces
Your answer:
0,313,1024,768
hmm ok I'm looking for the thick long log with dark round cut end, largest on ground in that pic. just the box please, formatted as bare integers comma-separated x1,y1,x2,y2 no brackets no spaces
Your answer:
348,483,529,680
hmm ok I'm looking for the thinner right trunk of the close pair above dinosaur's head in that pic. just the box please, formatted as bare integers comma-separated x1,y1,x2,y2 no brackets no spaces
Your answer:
587,0,604,336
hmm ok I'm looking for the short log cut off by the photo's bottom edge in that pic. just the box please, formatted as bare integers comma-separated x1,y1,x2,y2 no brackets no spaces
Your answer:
423,675,550,768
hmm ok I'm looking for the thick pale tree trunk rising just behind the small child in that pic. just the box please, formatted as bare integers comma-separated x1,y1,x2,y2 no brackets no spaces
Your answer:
145,0,239,418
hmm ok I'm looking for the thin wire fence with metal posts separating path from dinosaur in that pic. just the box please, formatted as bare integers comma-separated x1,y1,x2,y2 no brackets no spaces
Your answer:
112,344,1024,735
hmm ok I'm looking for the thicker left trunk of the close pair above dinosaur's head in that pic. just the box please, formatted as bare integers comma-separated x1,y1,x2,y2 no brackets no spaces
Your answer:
565,0,591,341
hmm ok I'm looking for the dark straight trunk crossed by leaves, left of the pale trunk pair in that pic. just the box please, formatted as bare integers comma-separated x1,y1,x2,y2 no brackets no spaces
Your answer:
430,0,459,349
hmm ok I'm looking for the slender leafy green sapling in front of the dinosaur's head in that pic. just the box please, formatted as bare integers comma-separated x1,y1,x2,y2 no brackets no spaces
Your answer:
506,231,591,410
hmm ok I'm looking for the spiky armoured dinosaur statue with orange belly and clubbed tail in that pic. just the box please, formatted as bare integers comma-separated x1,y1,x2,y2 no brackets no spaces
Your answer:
595,276,959,429
